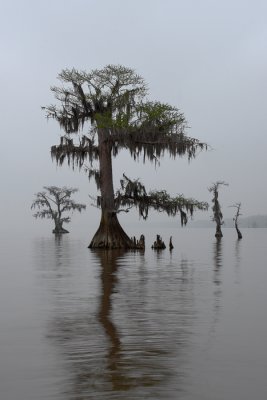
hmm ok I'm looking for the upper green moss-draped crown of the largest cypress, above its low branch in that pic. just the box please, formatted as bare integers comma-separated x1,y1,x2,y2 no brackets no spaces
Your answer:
46,65,207,180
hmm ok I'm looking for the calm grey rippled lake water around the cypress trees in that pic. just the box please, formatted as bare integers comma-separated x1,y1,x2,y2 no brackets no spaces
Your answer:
0,229,267,400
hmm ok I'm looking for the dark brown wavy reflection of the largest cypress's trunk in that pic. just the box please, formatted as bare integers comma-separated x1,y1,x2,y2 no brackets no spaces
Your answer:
93,250,174,391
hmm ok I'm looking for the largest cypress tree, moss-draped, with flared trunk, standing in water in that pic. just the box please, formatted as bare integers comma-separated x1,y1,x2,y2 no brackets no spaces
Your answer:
43,65,207,248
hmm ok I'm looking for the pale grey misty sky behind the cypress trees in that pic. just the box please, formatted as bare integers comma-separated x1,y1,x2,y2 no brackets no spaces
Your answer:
0,0,267,232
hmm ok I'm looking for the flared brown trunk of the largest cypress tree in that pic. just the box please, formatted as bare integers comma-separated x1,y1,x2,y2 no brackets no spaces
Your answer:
88,128,133,249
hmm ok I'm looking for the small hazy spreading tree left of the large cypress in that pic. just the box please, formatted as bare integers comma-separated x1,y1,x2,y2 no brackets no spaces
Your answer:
31,186,86,233
